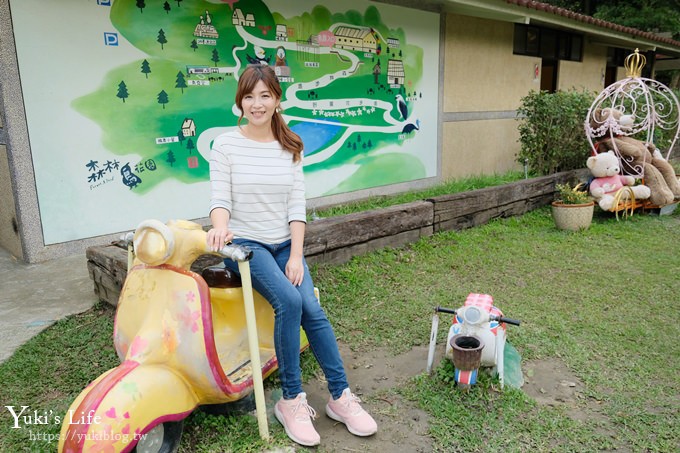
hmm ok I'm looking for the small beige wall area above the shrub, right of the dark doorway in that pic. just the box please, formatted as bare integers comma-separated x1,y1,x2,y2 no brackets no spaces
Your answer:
557,42,607,93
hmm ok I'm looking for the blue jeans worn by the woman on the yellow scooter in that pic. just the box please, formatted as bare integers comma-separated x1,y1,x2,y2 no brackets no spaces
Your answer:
224,238,349,399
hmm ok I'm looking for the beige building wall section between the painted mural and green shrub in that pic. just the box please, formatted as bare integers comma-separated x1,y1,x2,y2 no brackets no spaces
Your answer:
441,14,541,180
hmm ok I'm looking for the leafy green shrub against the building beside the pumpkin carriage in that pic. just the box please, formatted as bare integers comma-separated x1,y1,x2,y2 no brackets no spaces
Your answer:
517,90,595,175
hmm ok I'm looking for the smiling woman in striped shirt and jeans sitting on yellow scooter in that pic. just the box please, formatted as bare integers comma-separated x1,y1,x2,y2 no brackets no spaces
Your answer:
208,66,378,446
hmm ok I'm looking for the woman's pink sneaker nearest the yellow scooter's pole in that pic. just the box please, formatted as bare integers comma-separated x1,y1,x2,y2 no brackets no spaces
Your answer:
274,392,321,447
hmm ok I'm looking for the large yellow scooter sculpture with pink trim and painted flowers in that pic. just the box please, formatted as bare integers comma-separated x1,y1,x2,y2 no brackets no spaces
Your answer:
59,220,309,452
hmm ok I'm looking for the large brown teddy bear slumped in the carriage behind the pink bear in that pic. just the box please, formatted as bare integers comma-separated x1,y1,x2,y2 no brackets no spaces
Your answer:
590,108,680,206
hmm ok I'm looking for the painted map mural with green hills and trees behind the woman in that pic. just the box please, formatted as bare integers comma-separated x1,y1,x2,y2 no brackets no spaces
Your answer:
10,0,439,244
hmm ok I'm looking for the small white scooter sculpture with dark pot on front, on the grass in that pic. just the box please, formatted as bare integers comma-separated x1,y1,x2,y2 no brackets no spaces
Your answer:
427,293,520,388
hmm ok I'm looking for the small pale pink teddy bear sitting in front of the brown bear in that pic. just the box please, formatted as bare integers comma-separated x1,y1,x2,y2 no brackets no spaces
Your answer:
586,151,651,211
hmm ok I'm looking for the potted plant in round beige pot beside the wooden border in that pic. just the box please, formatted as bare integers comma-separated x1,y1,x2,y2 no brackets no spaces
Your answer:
552,184,595,231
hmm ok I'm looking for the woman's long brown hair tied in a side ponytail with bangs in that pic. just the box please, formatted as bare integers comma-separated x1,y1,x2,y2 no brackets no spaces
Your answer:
236,65,304,162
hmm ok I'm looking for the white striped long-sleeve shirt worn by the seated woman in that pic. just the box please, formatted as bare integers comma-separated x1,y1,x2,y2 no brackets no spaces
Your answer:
210,130,306,244
